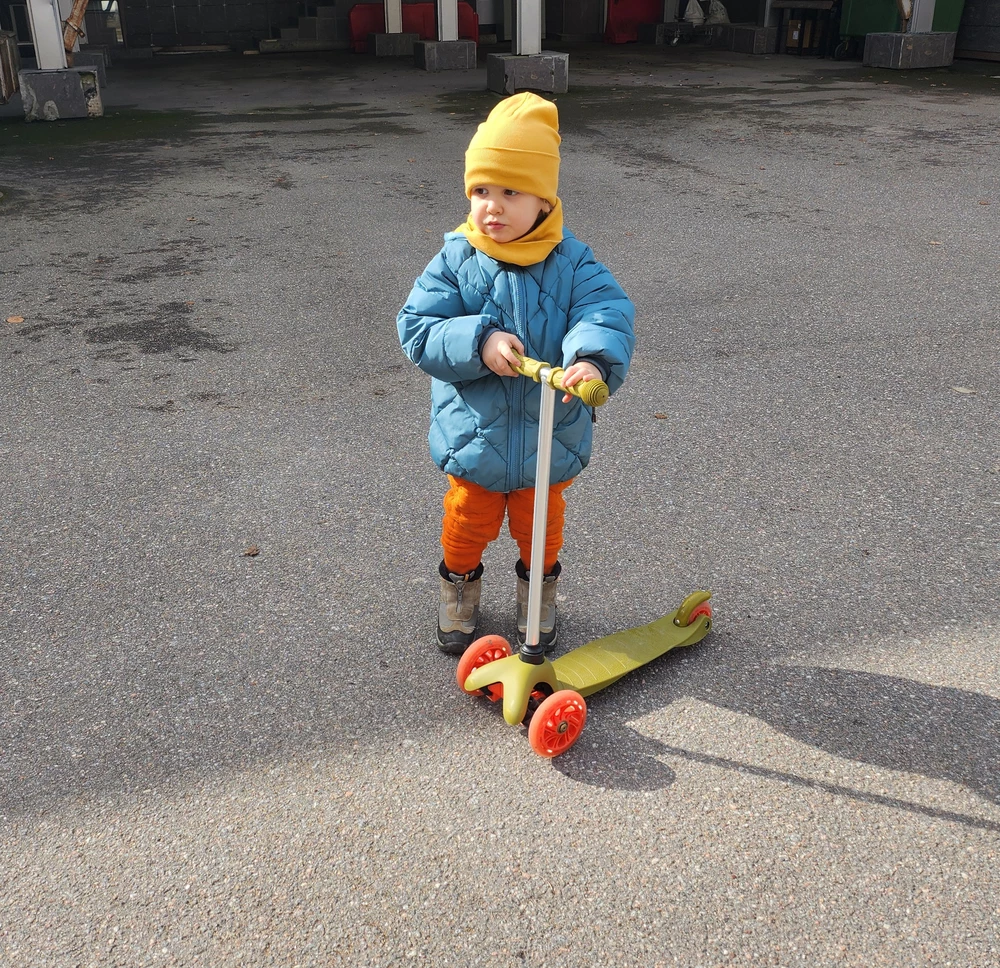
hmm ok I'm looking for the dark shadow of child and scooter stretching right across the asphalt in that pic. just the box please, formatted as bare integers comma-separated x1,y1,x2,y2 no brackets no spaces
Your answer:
555,663,1000,829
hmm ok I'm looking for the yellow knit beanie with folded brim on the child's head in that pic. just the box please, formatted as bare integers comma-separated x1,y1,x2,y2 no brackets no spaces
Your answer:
465,92,562,205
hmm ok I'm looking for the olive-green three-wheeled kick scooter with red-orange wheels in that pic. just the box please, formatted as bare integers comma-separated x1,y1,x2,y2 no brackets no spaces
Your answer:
456,357,712,757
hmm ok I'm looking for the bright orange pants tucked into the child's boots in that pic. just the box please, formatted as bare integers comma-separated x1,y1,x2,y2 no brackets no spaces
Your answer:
441,474,573,575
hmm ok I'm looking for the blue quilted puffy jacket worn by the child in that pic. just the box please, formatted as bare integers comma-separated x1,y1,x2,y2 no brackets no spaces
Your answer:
396,230,635,493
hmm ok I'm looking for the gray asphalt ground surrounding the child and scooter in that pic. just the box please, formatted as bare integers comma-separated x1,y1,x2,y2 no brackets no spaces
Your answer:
0,46,1000,968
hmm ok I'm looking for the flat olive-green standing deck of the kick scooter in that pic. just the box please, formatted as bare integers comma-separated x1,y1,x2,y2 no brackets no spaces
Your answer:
552,609,712,696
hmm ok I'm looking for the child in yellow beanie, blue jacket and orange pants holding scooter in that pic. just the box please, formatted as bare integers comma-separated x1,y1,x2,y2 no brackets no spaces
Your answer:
396,93,635,655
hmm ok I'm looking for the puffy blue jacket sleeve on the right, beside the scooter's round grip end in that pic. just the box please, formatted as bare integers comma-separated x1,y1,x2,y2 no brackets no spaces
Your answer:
562,246,635,393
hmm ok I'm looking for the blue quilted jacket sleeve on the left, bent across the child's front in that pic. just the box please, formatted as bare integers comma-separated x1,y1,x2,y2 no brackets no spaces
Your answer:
396,249,496,383
